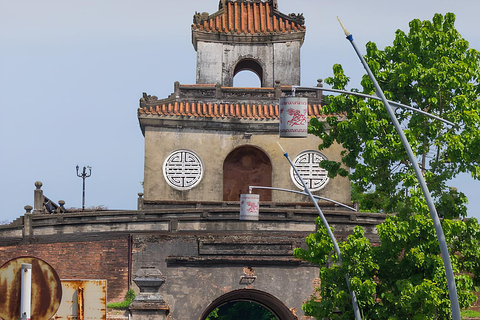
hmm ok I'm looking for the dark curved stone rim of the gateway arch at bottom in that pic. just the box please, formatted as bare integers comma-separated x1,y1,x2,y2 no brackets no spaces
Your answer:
200,289,296,320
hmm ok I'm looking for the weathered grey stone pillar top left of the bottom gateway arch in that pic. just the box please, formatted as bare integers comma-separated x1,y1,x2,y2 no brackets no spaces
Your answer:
129,268,170,320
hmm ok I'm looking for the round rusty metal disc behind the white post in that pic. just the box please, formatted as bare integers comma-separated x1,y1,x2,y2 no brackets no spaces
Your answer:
0,257,62,320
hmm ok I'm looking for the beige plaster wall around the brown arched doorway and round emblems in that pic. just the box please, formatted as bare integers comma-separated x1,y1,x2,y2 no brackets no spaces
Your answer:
144,127,351,203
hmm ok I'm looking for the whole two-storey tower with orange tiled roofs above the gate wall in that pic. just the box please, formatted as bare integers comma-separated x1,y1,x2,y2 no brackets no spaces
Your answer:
138,0,350,205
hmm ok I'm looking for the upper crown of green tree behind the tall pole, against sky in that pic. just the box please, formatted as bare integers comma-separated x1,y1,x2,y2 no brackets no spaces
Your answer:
309,13,480,217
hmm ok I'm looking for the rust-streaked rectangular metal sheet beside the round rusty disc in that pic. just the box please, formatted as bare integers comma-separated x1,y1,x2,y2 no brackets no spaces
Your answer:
54,280,107,320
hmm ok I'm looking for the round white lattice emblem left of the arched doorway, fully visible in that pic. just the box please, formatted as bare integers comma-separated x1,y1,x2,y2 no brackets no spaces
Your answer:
163,150,203,190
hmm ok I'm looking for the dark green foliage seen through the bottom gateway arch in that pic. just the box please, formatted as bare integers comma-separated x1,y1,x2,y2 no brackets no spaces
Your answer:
206,301,277,320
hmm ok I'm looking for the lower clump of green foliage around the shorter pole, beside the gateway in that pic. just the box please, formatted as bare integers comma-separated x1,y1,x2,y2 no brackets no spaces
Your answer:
295,214,480,320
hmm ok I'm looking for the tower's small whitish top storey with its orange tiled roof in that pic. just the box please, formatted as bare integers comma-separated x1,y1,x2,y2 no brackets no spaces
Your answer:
192,0,305,87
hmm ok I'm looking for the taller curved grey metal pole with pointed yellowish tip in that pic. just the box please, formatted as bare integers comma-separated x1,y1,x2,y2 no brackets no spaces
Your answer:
338,19,461,320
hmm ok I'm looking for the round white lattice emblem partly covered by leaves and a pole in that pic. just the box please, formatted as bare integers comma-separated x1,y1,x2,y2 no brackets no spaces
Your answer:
290,150,329,191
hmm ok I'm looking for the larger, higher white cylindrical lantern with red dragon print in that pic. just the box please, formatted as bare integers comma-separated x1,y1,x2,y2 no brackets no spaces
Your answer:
279,97,308,138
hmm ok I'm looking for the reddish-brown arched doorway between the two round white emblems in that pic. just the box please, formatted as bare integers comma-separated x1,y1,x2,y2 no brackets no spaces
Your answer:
223,146,272,201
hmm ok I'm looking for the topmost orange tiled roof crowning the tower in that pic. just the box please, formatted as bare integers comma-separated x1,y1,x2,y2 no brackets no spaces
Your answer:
192,0,305,34
